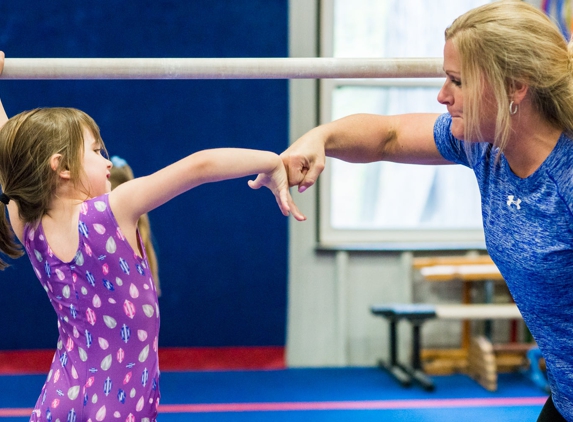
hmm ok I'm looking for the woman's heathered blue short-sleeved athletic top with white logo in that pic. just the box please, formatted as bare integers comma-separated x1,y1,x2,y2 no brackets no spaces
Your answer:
434,114,573,421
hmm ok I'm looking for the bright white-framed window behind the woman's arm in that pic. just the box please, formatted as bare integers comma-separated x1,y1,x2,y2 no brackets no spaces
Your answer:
319,0,487,249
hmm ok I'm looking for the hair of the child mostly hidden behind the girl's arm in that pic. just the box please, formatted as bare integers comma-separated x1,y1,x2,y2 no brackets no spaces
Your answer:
109,157,161,295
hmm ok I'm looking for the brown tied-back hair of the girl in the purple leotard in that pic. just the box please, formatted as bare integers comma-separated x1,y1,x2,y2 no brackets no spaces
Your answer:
0,108,105,269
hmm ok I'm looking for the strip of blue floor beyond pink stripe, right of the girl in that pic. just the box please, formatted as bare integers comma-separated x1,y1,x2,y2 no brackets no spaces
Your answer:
161,368,545,404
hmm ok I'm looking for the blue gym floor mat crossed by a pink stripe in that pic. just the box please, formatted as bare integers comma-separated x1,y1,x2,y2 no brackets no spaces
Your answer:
0,368,547,422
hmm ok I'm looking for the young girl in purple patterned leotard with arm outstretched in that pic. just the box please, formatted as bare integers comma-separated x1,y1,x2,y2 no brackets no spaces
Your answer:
0,108,304,422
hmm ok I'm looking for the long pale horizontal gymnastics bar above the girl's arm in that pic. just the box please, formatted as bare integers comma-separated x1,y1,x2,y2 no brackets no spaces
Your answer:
0,57,444,80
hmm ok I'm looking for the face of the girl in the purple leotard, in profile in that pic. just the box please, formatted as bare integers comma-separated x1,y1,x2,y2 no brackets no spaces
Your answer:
82,128,112,198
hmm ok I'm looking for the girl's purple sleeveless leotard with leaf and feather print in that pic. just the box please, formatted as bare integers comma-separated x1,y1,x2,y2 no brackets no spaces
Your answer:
24,195,160,422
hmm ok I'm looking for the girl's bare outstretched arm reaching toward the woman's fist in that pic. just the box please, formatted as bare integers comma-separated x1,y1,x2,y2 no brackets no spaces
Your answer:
109,148,305,237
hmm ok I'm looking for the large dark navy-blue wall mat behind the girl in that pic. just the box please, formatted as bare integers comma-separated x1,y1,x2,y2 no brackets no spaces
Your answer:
0,0,288,349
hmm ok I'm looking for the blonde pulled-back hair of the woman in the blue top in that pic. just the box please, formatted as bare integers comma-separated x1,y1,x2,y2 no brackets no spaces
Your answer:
445,0,573,151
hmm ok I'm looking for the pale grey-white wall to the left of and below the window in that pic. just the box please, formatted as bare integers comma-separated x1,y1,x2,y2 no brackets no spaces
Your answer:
287,0,412,366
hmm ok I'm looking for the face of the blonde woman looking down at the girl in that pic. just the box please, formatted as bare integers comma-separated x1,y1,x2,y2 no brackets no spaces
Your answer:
438,40,497,142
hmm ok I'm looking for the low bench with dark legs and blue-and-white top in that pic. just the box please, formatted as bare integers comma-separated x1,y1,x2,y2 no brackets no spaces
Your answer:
370,304,521,391
